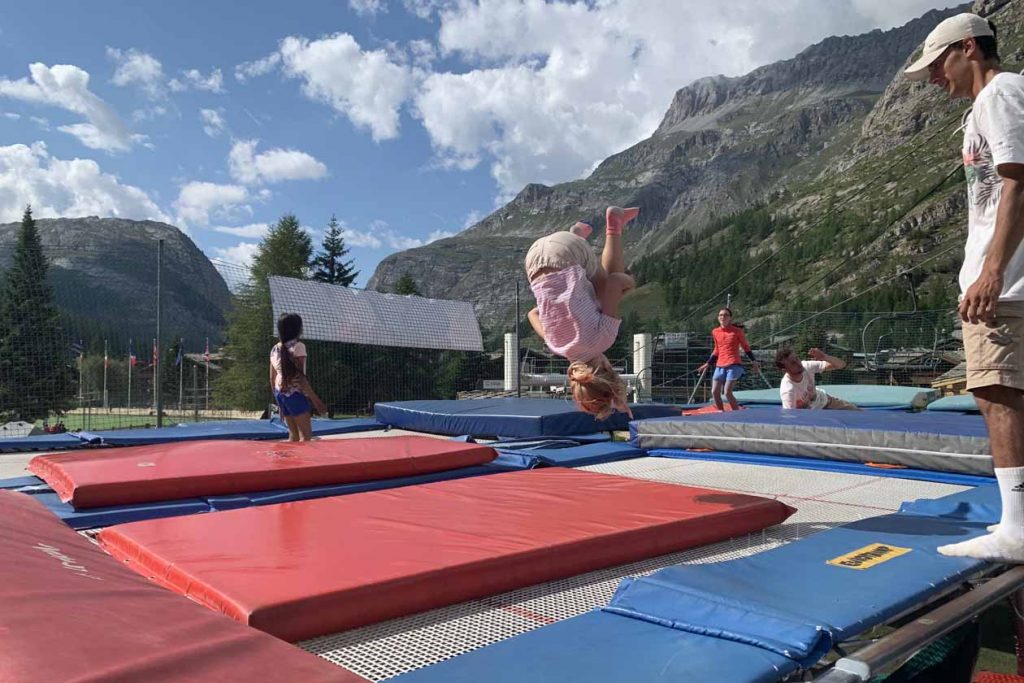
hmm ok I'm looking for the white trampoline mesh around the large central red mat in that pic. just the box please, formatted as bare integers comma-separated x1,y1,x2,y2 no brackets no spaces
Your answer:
298,458,966,681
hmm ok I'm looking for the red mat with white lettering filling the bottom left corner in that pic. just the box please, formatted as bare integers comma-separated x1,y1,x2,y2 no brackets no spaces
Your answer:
0,490,364,683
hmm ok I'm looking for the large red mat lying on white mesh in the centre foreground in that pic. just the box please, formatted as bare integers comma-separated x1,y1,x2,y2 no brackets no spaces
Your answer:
98,468,795,641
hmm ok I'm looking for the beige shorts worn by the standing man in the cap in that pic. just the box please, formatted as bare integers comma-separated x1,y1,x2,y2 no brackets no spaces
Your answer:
964,301,1024,391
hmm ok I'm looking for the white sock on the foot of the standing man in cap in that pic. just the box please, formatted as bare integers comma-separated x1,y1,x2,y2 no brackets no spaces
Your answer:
939,467,1024,564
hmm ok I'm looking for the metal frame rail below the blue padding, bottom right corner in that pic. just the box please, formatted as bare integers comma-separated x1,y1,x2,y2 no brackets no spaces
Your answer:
816,566,1024,683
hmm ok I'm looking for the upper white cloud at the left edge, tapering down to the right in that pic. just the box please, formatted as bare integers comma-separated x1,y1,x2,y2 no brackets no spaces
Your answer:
0,62,138,152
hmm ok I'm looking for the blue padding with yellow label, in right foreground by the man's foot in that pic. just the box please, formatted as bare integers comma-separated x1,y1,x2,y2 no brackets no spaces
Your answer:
393,487,998,683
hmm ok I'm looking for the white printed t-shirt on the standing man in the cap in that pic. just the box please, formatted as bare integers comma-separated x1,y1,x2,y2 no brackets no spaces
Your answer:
959,73,1024,301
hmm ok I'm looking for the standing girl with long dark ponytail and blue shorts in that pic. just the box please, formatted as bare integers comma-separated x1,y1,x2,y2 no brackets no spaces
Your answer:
270,313,327,441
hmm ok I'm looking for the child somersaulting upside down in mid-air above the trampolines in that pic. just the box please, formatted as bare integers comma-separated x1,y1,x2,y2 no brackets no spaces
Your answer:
525,207,640,420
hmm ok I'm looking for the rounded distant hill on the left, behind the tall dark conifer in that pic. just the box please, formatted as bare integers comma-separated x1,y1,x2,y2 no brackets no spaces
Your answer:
0,216,230,348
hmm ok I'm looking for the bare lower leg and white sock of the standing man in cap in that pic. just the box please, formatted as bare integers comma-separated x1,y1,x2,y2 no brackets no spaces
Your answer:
939,385,1024,563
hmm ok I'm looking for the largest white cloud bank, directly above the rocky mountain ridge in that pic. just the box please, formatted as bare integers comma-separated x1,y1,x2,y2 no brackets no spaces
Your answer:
407,0,944,199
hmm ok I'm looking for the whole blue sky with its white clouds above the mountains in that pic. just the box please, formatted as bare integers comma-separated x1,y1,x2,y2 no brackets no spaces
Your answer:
0,0,949,284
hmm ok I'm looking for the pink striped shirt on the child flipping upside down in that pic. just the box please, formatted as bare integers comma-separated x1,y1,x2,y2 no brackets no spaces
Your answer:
529,265,620,360
